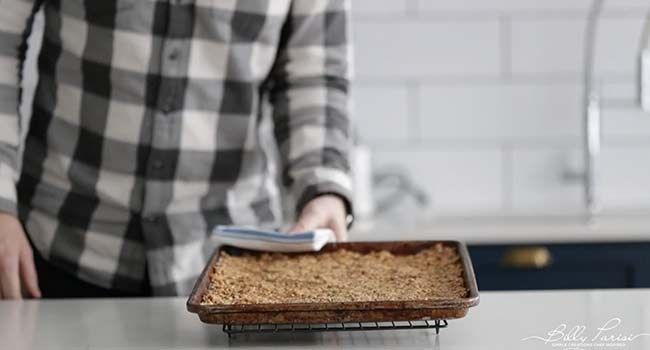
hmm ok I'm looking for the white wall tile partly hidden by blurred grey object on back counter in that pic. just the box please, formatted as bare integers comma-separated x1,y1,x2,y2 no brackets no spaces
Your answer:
373,149,503,213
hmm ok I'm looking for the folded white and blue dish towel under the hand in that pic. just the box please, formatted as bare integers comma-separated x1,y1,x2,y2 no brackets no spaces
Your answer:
213,226,336,253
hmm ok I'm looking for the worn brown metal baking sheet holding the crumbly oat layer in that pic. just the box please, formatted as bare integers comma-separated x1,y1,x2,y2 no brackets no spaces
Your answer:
187,241,479,324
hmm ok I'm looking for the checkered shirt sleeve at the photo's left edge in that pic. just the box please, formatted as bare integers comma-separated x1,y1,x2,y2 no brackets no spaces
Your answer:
0,0,40,214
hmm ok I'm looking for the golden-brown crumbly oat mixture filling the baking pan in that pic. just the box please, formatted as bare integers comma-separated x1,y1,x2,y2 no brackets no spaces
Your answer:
201,244,467,305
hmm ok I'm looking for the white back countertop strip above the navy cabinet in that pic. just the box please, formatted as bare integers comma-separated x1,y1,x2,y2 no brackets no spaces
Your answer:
350,213,650,245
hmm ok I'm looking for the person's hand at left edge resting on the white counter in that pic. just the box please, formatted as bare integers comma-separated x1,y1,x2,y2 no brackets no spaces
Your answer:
0,213,41,299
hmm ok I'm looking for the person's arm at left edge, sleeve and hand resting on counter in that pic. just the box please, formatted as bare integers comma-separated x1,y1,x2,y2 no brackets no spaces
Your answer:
0,0,40,299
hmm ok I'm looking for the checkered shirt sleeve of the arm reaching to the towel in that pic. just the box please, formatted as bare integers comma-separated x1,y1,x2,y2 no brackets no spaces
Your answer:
270,0,352,213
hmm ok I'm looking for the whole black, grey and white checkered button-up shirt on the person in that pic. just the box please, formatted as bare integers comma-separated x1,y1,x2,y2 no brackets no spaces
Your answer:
0,0,350,295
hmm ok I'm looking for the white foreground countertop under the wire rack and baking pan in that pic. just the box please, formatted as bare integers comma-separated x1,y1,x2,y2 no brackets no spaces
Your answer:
0,289,650,350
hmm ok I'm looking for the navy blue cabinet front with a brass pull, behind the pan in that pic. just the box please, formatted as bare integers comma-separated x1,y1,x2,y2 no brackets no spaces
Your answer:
469,242,650,290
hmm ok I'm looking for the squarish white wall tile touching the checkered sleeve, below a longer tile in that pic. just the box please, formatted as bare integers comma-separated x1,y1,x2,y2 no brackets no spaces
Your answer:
352,84,410,145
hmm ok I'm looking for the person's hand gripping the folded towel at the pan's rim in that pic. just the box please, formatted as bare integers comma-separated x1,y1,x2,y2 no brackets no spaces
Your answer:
289,194,348,241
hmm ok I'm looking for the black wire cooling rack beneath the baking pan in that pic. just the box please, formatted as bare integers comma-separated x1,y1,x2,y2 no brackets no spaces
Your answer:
223,320,448,337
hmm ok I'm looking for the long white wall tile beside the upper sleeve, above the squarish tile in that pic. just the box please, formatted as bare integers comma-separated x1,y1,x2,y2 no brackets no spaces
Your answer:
353,20,500,79
